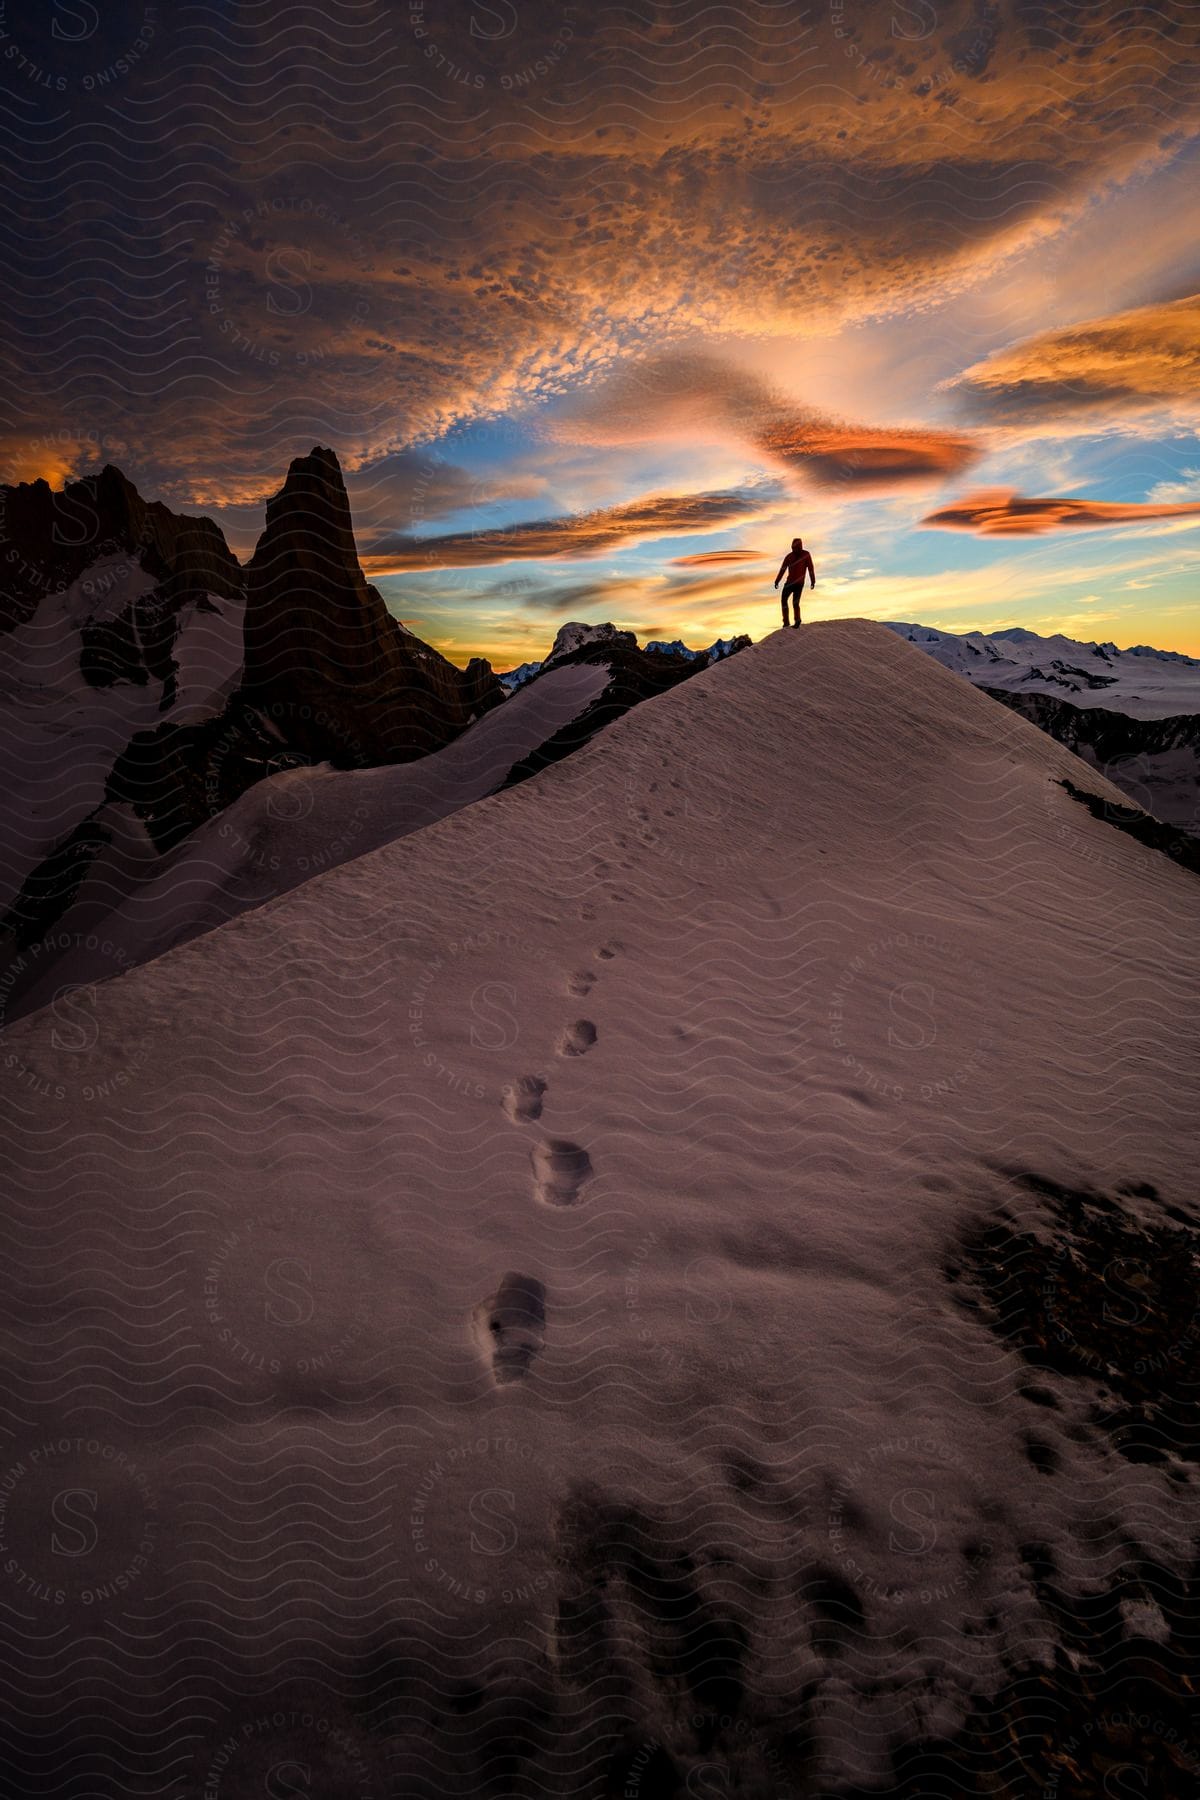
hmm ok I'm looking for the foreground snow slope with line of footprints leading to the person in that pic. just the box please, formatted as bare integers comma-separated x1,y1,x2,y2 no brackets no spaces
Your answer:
0,621,1200,1800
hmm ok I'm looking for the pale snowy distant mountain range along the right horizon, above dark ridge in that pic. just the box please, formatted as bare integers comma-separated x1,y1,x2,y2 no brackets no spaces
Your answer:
887,625,1200,718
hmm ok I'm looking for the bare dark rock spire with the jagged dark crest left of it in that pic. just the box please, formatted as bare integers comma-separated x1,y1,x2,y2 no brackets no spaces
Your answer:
0,446,504,763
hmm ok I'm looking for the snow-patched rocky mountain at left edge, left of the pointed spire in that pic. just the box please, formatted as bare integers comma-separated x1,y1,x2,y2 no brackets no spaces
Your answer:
0,468,243,941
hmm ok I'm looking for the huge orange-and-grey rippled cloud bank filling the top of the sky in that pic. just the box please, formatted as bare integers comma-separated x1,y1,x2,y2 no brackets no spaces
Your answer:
14,0,1200,506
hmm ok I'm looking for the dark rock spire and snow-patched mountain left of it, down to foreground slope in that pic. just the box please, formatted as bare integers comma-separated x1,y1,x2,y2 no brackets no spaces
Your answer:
0,448,504,1017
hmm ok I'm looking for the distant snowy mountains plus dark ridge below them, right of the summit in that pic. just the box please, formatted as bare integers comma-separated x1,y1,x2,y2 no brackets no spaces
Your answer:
889,625,1200,835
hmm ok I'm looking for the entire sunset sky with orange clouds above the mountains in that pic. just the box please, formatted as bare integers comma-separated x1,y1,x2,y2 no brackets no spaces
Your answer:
0,0,1200,668
